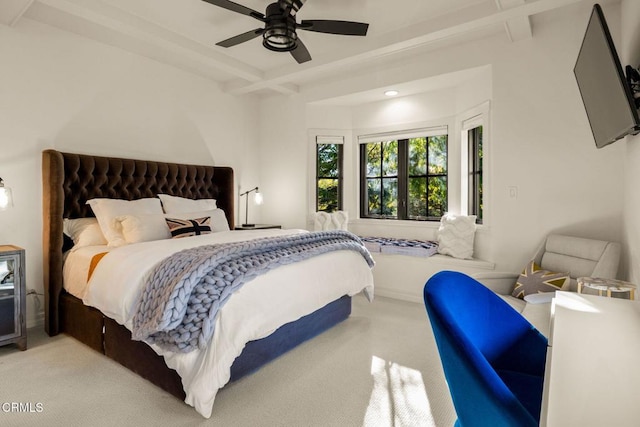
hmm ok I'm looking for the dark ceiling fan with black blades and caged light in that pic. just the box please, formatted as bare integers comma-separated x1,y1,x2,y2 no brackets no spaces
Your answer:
203,0,369,64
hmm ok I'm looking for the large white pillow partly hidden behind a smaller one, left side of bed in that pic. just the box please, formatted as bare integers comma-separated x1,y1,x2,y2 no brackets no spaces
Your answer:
87,198,162,247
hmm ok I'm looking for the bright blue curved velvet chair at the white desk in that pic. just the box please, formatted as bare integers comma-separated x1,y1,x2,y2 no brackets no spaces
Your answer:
424,271,547,427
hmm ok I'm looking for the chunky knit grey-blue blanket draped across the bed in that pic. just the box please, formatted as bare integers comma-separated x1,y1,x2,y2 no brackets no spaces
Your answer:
132,230,374,353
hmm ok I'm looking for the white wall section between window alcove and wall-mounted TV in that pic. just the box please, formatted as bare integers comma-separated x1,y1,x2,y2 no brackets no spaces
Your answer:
491,3,624,269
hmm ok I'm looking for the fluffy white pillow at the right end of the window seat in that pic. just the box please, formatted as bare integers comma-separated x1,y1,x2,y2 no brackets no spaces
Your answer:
437,213,476,259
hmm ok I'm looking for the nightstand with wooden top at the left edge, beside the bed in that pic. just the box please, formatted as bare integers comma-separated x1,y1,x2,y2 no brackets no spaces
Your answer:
0,245,27,350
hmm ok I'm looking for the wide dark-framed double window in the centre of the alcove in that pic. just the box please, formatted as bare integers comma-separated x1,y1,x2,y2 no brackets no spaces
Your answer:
359,128,448,221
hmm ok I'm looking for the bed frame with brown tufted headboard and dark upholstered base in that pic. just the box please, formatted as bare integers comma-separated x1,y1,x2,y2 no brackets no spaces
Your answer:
42,150,373,417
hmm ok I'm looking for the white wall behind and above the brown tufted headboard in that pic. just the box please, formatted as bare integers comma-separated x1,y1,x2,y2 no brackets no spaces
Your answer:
0,19,259,325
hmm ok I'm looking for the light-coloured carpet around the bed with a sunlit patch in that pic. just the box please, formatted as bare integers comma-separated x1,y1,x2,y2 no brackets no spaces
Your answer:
0,296,456,427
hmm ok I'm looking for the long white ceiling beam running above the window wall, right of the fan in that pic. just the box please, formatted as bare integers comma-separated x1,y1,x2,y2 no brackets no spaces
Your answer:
231,0,586,94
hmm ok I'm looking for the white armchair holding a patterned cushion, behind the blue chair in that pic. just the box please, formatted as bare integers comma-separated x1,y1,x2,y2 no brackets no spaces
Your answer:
473,234,621,336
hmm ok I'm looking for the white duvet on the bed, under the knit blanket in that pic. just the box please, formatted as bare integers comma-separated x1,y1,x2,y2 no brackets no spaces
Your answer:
83,229,373,418
